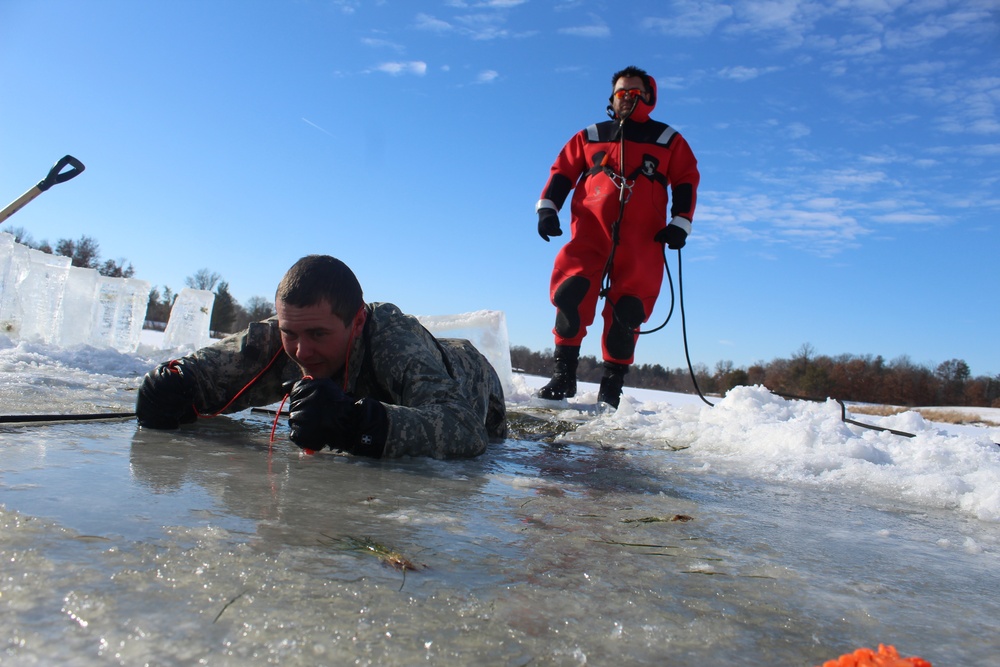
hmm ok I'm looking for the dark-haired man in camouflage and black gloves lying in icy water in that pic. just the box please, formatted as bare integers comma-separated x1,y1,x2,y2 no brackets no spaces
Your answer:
135,255,507,459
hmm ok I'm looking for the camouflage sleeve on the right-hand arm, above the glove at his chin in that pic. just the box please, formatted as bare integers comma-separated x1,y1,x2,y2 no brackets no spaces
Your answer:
370,316,488,459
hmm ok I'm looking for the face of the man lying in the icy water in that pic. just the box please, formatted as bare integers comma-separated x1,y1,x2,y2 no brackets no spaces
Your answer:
274,300,365,378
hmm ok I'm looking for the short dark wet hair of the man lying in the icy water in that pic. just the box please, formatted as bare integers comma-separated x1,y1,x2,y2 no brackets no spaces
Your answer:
274,255,364,325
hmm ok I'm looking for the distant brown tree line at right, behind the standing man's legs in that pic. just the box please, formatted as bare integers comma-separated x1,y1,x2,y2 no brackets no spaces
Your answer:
510,344,1000,408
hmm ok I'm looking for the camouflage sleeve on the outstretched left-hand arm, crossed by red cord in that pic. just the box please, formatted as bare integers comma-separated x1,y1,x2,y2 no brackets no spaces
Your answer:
181,318,298,416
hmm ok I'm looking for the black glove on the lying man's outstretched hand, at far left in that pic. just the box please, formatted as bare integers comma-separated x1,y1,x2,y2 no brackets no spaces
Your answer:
135,360,198,429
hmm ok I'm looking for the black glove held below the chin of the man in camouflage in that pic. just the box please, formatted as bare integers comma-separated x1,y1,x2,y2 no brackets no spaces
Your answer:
288,378,389,458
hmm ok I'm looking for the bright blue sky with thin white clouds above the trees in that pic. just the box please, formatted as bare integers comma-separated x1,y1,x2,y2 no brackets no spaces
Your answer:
0,0,1000,375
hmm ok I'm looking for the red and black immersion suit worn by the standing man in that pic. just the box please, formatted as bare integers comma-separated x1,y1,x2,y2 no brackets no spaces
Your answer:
536,77,700,364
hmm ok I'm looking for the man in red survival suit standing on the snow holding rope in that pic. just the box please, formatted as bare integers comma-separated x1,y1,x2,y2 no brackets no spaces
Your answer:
535,67,700,408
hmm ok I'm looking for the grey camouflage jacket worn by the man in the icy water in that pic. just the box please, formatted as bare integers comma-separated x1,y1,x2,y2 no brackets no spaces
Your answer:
182,303,507,459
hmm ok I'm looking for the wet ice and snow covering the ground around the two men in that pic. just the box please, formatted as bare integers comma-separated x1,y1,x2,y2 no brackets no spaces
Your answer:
0,272,1000,665
